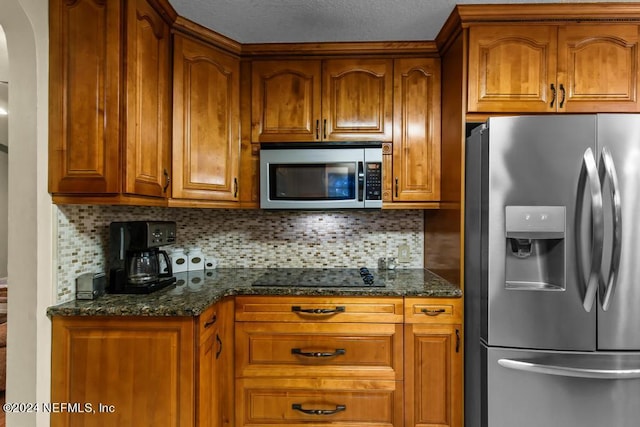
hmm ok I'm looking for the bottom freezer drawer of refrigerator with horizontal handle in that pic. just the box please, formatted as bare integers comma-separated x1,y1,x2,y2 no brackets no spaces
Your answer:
482,347,640,427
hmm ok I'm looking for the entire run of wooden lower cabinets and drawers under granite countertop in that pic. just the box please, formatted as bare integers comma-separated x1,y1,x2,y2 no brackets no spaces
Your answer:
51,296,463,427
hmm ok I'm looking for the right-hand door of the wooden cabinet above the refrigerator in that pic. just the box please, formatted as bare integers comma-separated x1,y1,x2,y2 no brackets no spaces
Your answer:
558,24,640,112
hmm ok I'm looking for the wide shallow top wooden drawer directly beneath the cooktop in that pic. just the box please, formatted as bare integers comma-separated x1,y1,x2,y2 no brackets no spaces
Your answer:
236,296,403,323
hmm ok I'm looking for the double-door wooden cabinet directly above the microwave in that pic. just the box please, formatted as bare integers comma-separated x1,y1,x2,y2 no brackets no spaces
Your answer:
251,59,393,142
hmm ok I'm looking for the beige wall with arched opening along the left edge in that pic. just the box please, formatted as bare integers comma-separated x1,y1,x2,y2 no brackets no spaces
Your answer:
0,0,54,427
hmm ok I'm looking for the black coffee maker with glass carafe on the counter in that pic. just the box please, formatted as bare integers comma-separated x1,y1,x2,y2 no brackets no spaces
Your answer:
107,221,176,294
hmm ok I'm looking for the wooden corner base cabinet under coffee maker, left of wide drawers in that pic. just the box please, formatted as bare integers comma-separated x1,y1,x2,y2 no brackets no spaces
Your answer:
51,299,234,427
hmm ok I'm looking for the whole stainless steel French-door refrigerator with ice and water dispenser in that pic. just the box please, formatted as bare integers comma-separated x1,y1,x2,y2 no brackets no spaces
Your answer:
465,114,640,427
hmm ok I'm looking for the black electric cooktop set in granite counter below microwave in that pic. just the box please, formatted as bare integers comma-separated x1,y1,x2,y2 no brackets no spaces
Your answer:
252,267,384,288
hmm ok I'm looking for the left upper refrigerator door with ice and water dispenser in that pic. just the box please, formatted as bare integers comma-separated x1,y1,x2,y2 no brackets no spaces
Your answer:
479,115,601,350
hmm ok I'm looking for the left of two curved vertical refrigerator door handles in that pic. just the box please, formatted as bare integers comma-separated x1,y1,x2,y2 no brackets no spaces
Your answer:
575,148,604,312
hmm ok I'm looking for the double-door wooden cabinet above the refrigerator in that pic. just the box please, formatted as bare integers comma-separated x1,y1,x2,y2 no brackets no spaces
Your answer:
468,23,640,113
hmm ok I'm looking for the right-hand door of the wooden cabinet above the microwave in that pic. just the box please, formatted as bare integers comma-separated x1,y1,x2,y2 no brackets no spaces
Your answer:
321,59,393,141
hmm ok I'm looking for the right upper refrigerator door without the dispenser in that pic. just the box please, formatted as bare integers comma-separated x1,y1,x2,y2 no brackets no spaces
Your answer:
597,114,640,350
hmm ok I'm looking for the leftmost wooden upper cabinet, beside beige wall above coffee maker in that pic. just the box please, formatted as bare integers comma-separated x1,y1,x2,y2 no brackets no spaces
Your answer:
49,0,171,205
